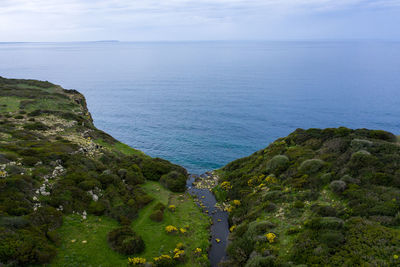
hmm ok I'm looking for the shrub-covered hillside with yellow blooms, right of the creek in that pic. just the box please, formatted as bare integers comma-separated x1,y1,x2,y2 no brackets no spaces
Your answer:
214,128,400,267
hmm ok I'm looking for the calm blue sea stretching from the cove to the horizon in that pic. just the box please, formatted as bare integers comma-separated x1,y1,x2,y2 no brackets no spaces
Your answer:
0,41,400,173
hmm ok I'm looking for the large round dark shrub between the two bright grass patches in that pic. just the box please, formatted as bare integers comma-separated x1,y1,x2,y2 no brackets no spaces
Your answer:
107,226,145,255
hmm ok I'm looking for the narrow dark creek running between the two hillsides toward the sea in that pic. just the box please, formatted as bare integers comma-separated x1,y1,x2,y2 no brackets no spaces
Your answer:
186,173,229,267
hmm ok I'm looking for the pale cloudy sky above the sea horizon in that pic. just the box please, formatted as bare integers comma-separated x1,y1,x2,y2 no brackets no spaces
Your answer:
0,0,400,42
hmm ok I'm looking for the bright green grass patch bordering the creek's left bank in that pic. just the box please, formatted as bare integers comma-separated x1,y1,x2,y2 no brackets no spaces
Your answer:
132,182,210,266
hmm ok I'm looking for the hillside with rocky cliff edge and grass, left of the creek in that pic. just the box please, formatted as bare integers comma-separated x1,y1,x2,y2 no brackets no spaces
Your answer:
0,77,209,266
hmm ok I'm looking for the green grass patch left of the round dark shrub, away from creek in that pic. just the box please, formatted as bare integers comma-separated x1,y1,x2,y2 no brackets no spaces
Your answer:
49,215,127,266
